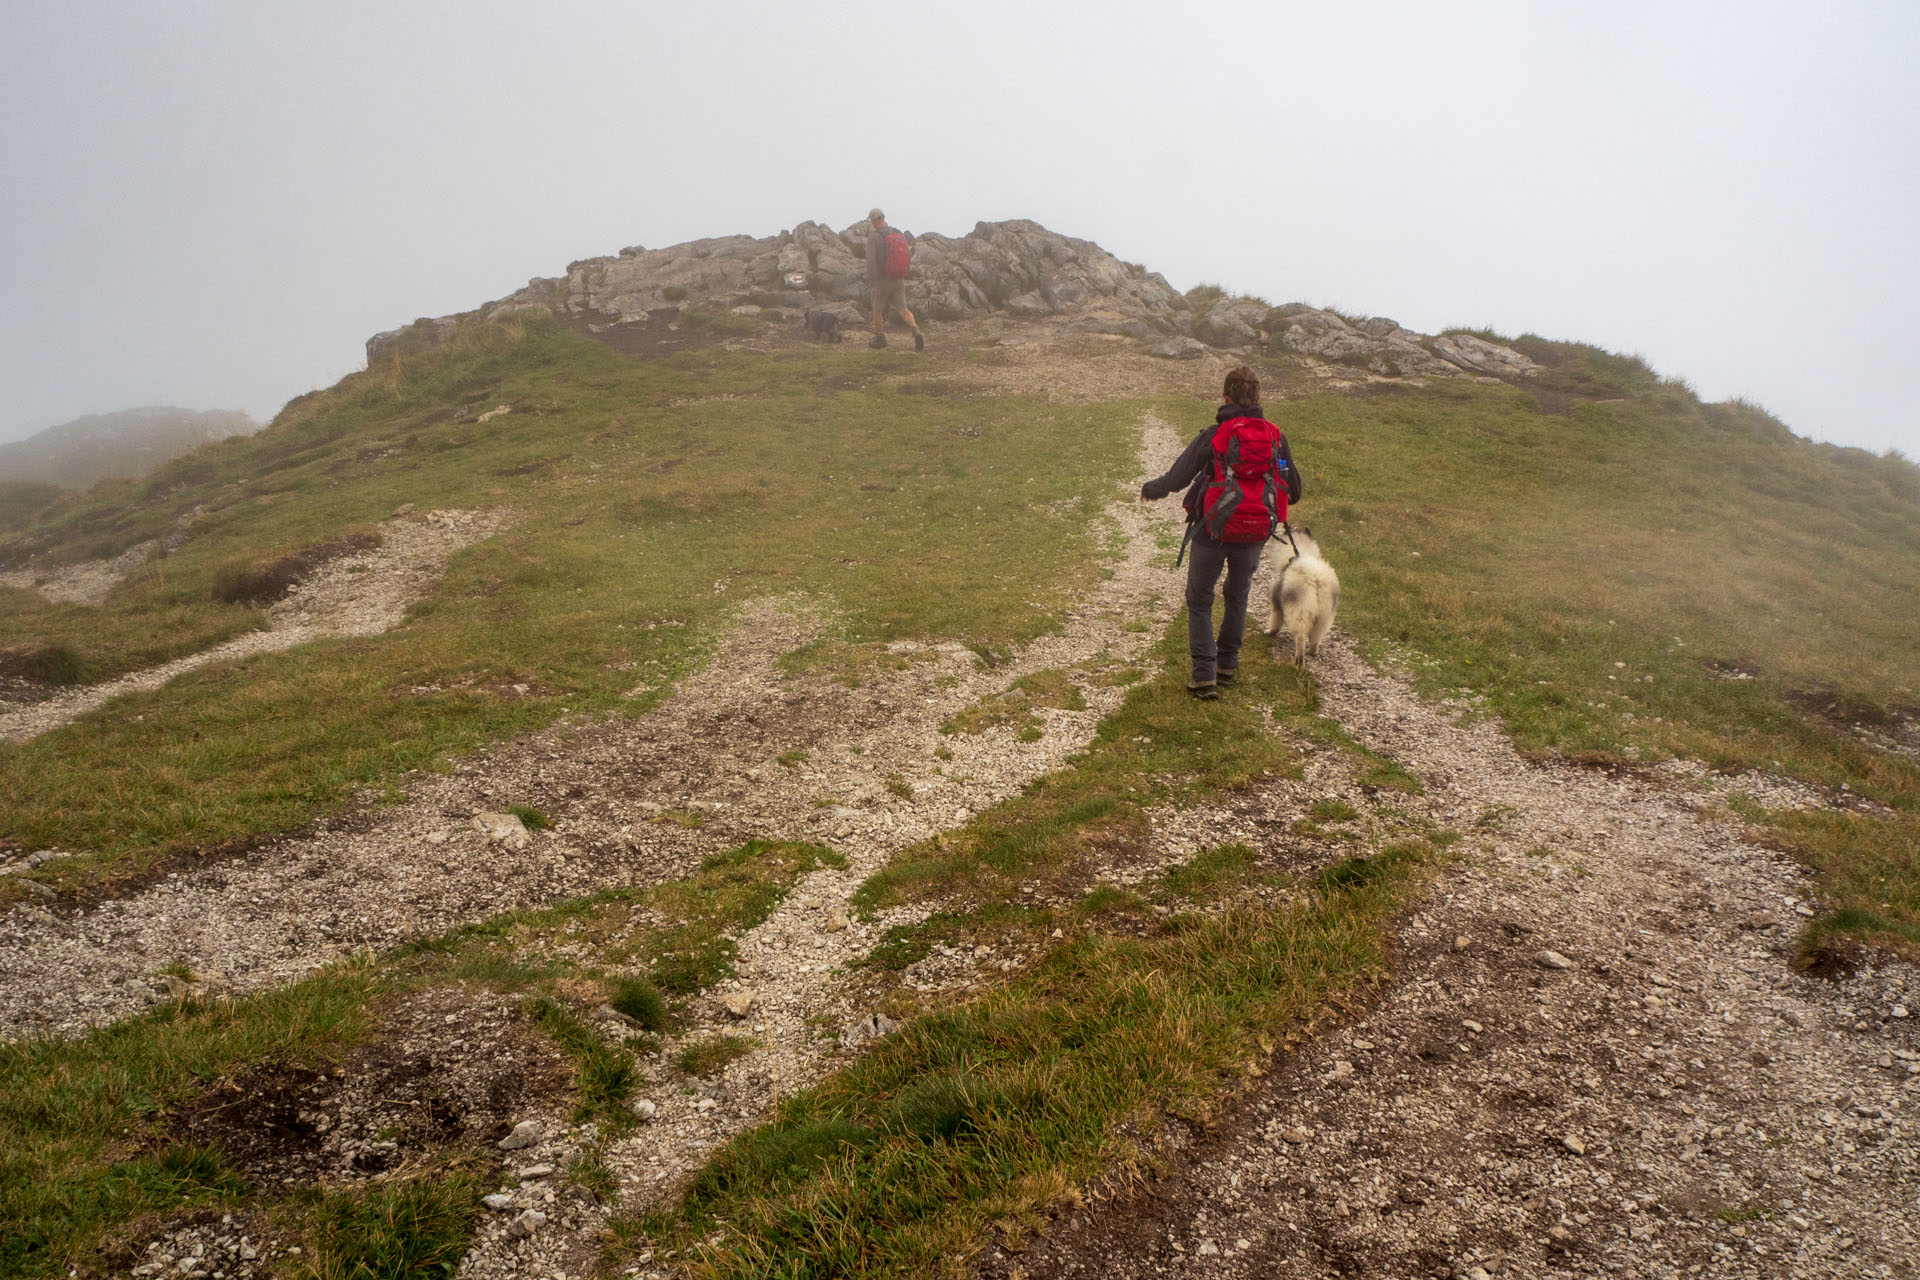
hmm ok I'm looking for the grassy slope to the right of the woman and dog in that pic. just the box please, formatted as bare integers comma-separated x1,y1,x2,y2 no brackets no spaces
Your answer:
1259,353,1920,954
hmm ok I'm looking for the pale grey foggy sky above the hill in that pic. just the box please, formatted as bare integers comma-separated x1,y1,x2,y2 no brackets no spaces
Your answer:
0,0,1920,457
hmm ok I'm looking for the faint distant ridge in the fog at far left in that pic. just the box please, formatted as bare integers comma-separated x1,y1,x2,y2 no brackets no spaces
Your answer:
0,407,259,487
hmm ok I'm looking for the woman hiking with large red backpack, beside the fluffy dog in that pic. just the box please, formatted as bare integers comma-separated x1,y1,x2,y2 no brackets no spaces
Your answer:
1140,365,1300,699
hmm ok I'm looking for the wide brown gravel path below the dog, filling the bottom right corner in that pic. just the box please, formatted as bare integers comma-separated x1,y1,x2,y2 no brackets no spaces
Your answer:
981,643,1920,1280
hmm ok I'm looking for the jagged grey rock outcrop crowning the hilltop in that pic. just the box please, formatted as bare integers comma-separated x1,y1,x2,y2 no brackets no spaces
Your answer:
367,210,1534,378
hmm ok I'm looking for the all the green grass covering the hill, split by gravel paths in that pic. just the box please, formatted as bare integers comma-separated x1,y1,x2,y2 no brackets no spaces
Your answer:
0,303,1920,1276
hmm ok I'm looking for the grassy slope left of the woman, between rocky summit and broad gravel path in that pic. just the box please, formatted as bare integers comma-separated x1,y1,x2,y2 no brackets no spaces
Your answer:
0,324,1133,901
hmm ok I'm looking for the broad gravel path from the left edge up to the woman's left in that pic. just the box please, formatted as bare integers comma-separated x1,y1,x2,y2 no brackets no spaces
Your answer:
0,420,1179,1043
